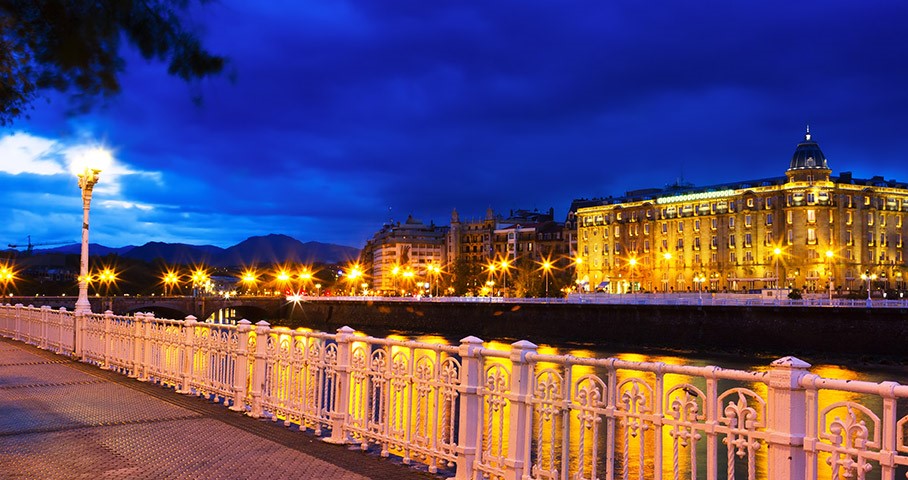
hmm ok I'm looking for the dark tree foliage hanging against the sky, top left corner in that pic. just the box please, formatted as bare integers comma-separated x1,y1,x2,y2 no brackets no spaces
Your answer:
0,0,226,125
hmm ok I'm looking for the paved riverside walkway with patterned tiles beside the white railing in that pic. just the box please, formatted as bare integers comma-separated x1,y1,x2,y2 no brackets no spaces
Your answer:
0,338,440,480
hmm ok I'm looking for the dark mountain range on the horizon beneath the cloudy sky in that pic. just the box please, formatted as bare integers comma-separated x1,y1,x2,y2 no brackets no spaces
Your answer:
17,234,359,267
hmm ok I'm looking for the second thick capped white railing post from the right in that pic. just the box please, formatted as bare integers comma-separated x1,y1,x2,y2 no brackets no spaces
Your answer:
504,340,536,480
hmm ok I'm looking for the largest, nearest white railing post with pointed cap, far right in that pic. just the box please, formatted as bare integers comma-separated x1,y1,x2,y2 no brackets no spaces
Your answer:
767,357,810,480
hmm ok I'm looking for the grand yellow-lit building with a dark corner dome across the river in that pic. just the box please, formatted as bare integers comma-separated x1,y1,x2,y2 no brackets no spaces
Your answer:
573,128,908,293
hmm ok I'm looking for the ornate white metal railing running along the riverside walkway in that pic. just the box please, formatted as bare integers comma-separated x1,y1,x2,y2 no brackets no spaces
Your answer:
0,305,908,480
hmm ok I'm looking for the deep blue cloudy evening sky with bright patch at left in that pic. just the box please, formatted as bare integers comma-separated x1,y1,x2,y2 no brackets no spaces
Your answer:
0,0,908,251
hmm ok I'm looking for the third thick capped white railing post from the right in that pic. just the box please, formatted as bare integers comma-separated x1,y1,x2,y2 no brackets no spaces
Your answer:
454,336,482,480
